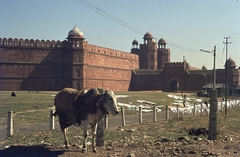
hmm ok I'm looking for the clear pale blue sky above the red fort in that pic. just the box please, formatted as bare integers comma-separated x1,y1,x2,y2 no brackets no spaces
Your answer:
0,0,240,69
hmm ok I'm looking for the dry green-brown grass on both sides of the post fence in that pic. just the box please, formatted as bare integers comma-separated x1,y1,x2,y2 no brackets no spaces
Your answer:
0,91,240,150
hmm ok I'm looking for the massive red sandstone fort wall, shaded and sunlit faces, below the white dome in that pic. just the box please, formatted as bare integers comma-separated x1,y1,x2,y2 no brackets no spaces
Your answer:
0,38,138,91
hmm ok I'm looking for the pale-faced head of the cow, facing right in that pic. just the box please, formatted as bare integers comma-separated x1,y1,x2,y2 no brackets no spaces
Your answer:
96,90,119,115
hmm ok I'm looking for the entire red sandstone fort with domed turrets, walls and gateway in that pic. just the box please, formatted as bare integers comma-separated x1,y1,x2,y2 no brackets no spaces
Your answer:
0,27,240,93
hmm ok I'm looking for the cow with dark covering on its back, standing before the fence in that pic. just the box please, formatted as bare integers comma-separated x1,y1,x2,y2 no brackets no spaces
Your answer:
54,88,119,153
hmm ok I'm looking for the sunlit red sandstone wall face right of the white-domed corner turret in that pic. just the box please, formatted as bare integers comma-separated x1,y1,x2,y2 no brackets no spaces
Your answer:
83,45,139,91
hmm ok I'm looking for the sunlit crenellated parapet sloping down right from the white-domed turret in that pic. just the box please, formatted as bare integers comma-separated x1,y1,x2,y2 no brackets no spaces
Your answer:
84,44,138,60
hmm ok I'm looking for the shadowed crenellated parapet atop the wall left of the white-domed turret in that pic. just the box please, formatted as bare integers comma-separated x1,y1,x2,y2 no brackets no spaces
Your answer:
0,38,63,48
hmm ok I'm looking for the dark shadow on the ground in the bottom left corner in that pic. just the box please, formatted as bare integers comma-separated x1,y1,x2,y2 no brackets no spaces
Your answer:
0,146,64,157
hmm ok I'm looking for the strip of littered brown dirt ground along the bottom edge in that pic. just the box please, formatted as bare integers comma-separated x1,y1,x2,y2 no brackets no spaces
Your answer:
0,128,240,157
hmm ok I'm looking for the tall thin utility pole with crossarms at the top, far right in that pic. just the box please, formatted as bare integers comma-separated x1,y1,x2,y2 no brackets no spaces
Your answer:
223,37,231,116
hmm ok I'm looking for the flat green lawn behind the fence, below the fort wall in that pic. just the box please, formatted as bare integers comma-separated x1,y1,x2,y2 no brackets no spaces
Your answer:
0,91,187,125
